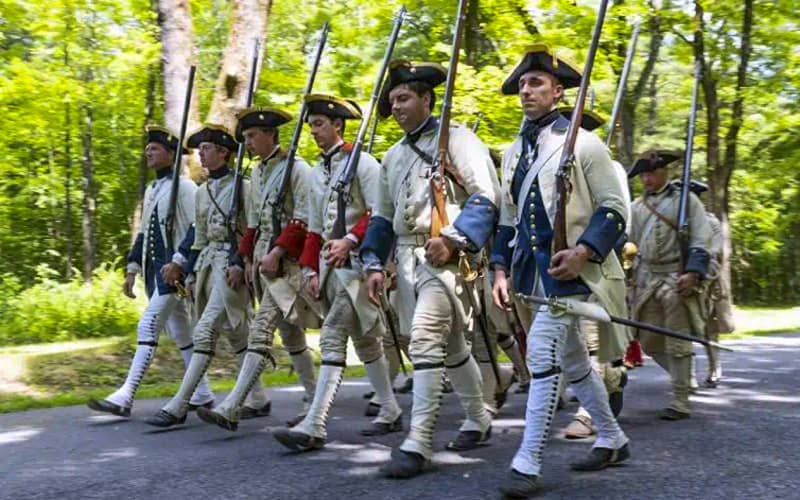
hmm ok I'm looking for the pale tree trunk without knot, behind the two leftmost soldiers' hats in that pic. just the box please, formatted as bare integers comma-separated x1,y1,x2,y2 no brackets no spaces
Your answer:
158,0,200,134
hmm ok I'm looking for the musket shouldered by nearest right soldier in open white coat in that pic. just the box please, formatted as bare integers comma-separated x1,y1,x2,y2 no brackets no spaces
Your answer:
553,0,608,255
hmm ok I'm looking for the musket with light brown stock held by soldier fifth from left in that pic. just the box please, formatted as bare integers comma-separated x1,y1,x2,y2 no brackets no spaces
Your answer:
430,0,467,238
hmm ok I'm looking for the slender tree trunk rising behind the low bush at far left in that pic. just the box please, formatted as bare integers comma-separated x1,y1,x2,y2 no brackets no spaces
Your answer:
81,97,97,281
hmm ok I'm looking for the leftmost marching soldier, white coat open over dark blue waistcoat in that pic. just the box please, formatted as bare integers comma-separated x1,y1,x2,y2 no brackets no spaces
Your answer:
88,126,214,417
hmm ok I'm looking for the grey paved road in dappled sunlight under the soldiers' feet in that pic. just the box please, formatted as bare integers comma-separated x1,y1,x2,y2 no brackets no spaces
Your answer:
0,334,800,500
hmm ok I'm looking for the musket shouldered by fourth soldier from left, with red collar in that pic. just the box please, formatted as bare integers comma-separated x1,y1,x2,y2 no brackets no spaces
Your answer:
331,5,406,240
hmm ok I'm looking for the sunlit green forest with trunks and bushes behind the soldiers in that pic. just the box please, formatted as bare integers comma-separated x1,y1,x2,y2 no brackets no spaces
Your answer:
0,0,800,345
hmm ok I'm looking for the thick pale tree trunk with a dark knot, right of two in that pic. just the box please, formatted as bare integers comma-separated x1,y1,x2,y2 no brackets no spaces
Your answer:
205,0,272,130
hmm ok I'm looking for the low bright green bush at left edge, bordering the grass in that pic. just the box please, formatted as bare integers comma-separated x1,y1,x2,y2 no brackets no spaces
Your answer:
0,264,144,345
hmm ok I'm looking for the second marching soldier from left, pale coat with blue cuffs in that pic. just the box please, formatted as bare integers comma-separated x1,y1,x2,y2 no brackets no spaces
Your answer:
146,124,268,427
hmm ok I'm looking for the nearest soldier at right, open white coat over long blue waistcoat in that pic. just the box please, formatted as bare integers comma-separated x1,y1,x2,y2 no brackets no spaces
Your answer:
492,45,630,497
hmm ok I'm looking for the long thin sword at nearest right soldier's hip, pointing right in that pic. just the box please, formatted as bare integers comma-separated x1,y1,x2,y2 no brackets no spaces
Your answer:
517,293,735,352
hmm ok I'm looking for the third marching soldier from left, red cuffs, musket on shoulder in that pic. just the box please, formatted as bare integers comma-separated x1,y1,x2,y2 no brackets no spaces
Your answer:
198,107,317,431
